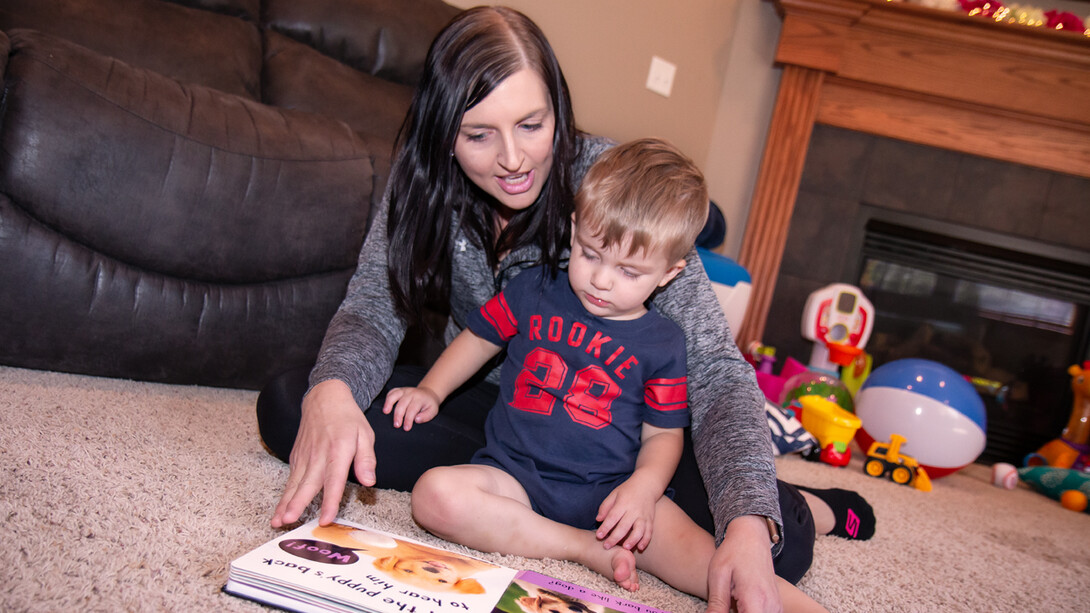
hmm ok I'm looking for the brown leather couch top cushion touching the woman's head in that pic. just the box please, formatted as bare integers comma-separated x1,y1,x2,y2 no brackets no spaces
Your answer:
265,0,459,85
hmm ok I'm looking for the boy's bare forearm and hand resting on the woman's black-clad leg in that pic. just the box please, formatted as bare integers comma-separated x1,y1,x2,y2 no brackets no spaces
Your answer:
383,328,501,431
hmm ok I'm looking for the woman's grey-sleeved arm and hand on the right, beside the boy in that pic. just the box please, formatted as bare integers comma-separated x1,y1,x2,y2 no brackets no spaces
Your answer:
655,250,783,613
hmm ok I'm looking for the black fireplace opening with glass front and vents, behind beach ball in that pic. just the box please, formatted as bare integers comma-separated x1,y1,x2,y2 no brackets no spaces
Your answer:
852,205,1090,466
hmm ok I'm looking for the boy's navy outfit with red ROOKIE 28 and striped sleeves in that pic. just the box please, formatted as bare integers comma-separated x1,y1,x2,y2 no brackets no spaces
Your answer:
468,268,689,519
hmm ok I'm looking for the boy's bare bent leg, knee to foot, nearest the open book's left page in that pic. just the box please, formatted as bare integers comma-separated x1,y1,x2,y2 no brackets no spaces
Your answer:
412,465,640,590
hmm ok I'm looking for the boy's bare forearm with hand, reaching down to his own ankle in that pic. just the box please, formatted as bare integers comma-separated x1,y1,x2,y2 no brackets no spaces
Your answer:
596,423,685,551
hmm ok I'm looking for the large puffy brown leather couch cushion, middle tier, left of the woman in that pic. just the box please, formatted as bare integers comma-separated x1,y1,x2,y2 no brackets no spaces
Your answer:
0,29,375,283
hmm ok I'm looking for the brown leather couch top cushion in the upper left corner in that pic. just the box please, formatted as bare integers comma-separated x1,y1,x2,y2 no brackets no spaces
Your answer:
0,0,262,99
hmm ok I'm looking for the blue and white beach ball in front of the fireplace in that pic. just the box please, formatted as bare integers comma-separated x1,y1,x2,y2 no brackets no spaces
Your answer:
856,359,988,479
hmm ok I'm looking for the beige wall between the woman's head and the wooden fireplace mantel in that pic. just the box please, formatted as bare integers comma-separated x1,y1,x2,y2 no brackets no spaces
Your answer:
448,0,779,255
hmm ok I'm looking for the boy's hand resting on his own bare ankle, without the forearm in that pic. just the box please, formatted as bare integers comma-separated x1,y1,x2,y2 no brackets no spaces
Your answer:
595,474,662,551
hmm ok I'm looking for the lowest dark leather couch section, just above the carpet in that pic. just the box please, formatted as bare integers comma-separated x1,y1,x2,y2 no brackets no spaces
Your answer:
0,194,351,389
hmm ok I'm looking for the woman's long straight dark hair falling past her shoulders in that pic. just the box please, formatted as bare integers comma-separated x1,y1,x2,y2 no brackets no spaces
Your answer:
387,7,578,324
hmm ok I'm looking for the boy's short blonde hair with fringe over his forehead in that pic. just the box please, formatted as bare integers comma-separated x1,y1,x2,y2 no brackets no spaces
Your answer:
574,139,710,264
